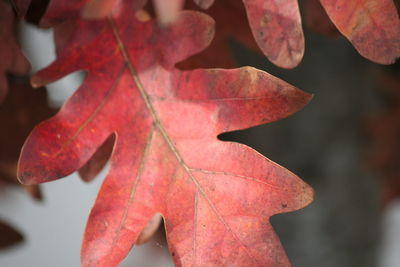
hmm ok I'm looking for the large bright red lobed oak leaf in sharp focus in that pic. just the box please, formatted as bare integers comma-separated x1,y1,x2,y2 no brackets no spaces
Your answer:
19,1,312,266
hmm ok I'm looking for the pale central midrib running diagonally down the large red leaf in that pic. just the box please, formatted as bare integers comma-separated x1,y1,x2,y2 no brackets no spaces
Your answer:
108,17,261,265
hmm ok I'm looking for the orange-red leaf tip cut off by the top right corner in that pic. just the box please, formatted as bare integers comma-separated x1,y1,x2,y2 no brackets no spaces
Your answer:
321,0,400,64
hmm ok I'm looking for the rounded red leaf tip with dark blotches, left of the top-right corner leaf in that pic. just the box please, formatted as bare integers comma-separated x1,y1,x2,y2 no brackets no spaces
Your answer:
194,0,304,69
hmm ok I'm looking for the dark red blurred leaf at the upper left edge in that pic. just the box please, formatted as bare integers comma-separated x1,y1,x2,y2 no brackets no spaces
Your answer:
0,1,30,102
